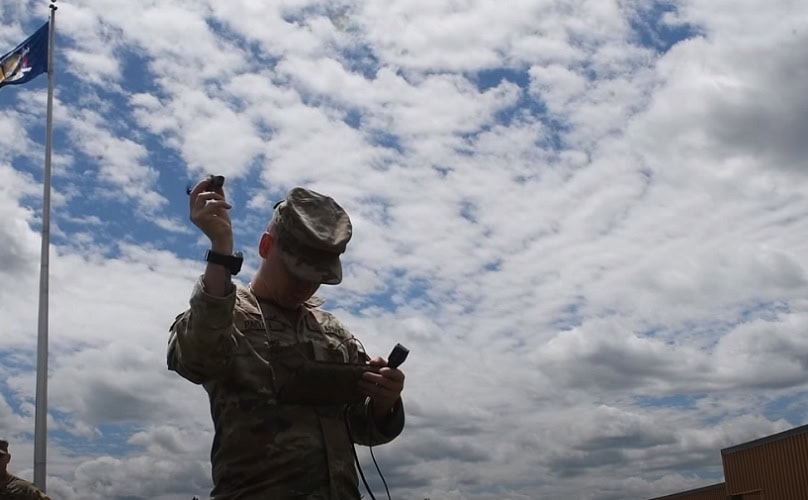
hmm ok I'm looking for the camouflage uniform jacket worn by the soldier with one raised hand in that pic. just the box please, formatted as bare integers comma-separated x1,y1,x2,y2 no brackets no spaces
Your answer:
168,188,404,500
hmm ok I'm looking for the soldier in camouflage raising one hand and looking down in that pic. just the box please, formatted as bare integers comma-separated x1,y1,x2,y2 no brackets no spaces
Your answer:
168,178,404,500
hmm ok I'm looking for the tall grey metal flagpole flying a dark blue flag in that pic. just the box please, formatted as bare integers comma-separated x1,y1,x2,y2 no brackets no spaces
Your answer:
34,0,57,491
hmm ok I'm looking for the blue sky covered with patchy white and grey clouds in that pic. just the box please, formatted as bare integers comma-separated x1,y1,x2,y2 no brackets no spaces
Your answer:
0,0,808,500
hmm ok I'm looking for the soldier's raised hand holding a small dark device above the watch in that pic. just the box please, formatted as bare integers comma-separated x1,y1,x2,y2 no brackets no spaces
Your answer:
189,177,233,253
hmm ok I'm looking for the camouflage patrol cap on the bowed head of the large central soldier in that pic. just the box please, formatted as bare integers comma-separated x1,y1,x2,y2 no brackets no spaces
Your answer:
273,187,353,285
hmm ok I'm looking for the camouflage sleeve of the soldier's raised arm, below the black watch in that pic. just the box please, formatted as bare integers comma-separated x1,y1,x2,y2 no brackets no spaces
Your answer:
167,277,236,384
